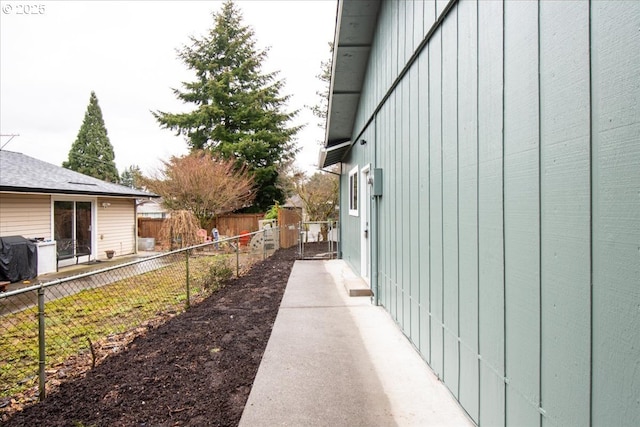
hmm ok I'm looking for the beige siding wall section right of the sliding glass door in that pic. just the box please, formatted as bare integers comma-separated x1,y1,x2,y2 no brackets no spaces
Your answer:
96,197,136,259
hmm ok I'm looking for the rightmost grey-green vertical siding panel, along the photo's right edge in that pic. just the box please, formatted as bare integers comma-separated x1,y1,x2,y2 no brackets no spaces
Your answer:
591,2,640,425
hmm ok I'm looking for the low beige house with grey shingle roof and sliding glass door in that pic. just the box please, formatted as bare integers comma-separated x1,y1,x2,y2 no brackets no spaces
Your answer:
0,150,157,274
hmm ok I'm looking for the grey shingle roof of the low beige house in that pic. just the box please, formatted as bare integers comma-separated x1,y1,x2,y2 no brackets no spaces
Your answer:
0,150,157,198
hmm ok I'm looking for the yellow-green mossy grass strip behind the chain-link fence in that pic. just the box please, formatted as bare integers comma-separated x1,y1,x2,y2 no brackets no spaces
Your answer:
0,255,228,397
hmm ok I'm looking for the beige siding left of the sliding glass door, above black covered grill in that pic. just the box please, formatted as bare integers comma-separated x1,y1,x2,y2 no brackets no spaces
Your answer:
0,193,52,240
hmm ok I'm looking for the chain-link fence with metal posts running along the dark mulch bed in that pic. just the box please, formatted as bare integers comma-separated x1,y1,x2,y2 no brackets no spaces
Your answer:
0,228,279,410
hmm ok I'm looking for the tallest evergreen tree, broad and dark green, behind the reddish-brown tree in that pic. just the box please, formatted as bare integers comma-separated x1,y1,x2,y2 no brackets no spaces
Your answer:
153,0,299,212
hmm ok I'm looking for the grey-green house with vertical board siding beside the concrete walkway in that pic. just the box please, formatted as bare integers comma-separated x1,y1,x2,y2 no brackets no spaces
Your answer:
320,0,640,426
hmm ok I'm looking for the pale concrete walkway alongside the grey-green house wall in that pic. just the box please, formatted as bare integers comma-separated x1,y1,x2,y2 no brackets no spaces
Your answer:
240,260,474,427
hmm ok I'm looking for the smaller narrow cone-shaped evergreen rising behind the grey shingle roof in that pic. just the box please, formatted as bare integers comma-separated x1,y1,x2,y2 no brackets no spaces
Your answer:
62,91,118,182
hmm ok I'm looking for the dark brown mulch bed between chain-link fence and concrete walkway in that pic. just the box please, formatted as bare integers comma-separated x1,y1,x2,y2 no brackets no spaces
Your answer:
1,247,306,427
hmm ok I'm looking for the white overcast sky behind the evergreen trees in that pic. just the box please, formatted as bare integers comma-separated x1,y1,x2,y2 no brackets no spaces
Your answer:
0,0,337,173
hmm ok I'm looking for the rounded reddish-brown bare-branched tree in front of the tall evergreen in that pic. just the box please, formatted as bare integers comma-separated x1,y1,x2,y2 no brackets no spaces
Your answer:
144,150,255,227
